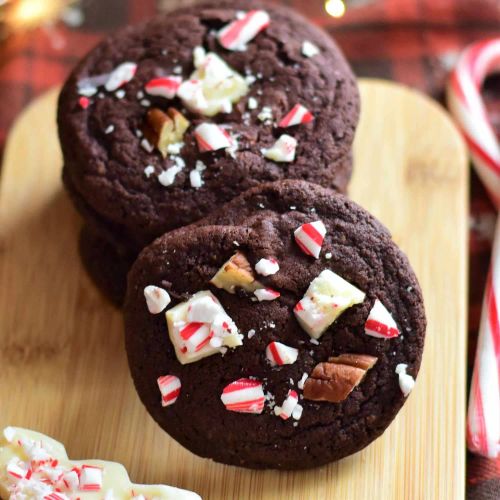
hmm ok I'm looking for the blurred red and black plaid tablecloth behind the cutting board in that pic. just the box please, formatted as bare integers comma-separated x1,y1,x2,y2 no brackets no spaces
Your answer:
0,0,500,500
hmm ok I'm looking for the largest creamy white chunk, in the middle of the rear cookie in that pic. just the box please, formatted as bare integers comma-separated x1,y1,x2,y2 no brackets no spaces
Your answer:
177,47,248,116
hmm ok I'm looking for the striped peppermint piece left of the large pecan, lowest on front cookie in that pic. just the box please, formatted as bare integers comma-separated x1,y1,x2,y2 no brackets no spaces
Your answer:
220,378,265,413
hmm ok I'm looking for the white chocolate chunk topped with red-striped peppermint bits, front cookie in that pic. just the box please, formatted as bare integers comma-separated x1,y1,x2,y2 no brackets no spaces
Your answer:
166,291,243,364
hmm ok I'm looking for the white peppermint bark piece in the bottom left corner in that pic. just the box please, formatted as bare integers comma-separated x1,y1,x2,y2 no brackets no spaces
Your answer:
0,427,201,500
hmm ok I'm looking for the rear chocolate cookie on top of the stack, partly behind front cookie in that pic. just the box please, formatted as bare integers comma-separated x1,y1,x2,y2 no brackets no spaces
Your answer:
58,0,359,252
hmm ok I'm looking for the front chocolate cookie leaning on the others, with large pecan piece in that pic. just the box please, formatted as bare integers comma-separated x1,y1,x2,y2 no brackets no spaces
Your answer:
125,183,426,469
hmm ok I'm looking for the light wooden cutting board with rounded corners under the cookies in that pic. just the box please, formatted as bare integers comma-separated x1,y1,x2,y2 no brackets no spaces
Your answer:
0,80,468,500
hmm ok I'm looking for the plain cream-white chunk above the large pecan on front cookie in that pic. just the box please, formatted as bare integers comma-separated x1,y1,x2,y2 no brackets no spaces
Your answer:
293,269,365,339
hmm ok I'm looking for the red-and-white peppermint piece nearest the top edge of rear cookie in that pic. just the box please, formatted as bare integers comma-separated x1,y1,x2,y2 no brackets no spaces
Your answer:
217,10,270,51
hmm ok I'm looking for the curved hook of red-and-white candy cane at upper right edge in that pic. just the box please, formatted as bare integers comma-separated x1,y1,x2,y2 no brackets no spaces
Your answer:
448,38,500,209
